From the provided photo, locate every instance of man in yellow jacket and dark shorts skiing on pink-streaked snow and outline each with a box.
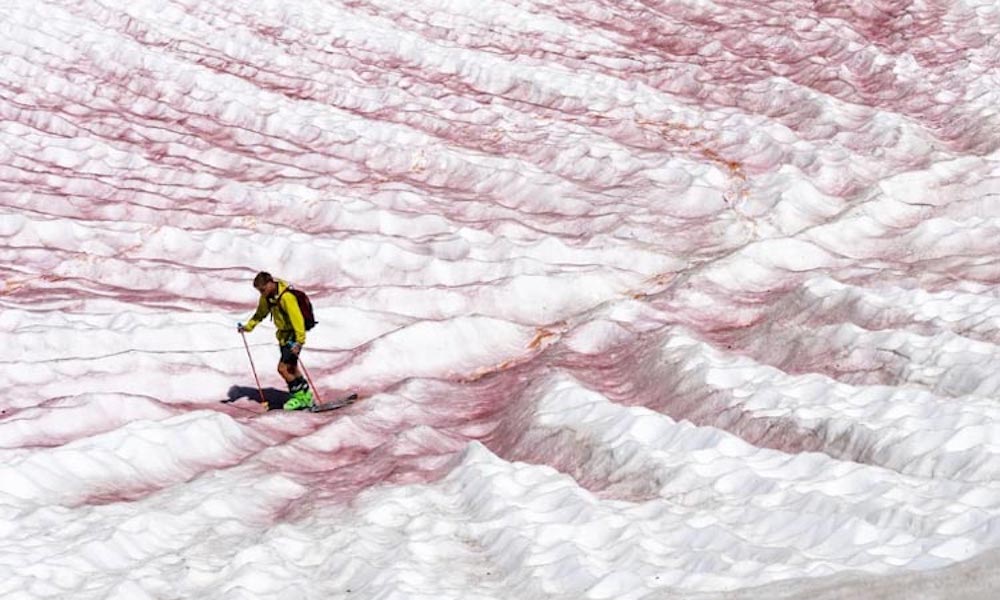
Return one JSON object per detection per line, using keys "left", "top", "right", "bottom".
{"left": 237, "top": 271, "right": 313, "bottom": 410}
